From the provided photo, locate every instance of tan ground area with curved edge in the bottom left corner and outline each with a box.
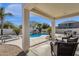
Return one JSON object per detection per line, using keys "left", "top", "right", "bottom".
{"left": 0, "top": 44, "right": 26, "bottom": 56}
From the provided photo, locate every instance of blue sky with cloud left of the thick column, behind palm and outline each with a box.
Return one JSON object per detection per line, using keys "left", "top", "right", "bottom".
{"left": 0, "top": 4, "right": 23, "bottom": 25}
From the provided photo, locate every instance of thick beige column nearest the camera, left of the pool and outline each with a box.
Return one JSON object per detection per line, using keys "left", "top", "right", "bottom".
{"left": 22, "top": 9, "right": 30, "bottom": 52}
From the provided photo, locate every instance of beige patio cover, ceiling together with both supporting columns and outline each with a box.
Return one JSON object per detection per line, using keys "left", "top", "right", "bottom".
{"left": 22, "top": 3, "right": 79, "bottom": 56}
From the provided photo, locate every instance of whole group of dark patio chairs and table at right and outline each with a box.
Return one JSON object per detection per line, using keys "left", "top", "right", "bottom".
{"left": 50, "top": 32, "right": 79, "bottom": 56}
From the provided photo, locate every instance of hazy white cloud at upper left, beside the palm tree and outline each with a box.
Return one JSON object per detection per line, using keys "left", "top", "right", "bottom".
{"left": 5, "top": 4, "right": 22, "bottom": 17}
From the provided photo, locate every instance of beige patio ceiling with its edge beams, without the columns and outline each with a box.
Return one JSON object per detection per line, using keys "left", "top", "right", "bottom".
{"left": 24, "top": 3, "right": 79, "bottom": 19}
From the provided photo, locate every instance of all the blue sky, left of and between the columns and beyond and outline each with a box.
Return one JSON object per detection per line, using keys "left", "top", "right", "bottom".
{"left": 0, "top": 3, "right": 79, "bottom": 26}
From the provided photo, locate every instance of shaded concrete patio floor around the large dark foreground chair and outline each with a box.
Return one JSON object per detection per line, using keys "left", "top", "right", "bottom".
{"left": 27, "top": 41, "right": 79, "bottom": 56}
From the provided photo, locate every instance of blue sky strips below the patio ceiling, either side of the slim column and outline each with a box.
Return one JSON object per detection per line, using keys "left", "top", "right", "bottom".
{"left": 30, "top": 14, "right": 79, "bottom": 26}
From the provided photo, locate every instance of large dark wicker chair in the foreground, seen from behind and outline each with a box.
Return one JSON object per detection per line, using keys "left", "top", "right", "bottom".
{"left": 50, "top": 42, "right": 78, "bottom": 56}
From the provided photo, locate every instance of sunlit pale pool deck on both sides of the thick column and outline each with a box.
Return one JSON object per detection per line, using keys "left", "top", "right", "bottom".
{"left": 5, "top": 35, "right": 48, "bottom": 48}
